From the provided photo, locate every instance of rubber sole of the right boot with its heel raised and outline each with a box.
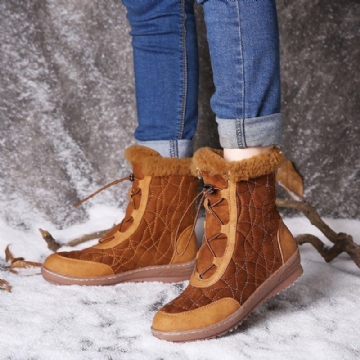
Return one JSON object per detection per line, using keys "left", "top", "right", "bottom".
{"left": 151, "top": 251, "right": 303, "bottom": 342}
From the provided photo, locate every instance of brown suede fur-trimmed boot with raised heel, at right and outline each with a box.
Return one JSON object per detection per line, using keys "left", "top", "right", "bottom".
{"left": 152, "top": 148, "right": 303, "bottom": 341}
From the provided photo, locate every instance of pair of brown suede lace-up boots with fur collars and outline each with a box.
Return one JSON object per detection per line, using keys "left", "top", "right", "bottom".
{"left": 42, "top": 145, "right": 302, "bottom": 341}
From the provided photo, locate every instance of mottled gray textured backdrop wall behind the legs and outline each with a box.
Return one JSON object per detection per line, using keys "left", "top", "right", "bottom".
{"left": 0, "top": 0, "right": 360, "bottom": 228}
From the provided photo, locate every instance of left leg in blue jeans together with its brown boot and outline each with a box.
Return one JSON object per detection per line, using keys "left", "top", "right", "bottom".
{"left": 42, "top": 0, "right": 202, "bottom": 285}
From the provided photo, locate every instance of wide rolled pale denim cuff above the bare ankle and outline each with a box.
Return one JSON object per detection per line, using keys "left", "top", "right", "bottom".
{"left": 216, "top": 113, "right": 283, "bottom": 149}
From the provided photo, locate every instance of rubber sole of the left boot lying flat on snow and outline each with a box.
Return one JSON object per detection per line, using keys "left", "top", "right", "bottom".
{"left": 41, "top": 260, "right": 195, "bottom": 286}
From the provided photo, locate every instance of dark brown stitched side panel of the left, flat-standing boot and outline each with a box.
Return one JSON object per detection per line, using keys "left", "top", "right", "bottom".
{"left": 61, "top": 176, "right": 198, "bottom": 273}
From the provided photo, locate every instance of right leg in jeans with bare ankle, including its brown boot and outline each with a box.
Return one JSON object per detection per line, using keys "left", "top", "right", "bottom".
{"left": 152, "top": 0, "right": 302, "bottom": 341}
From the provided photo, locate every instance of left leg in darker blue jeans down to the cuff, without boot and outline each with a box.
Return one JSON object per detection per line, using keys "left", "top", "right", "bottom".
{"left": 122, "top": 0, "right": 198, "bottom": 157}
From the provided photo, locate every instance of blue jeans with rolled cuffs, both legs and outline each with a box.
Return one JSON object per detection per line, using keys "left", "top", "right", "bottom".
{"left": 122, "top": 0, "right": 282, "bottom": 157}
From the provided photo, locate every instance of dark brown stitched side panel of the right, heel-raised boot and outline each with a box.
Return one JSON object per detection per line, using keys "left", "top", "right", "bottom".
{"left": 163, "top": 174, "right": 281, "bottom": 313}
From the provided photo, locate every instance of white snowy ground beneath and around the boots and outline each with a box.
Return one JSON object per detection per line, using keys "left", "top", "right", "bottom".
{"left": 0, "top": 205, "right": 360, "bottom": 360}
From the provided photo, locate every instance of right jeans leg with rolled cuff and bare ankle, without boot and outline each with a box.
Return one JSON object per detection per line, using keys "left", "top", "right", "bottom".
{"left": 200, "top": 0, "right": 282, "bottom": 160}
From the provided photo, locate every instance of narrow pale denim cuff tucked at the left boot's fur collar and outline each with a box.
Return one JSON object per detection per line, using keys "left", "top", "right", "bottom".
{"left": 136, "top": 140, "right": 193, "bottom": 158}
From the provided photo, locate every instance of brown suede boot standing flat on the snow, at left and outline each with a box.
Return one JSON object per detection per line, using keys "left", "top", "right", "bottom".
{"left": 41, "top": 145, "right": 198, "bottom": 285}
